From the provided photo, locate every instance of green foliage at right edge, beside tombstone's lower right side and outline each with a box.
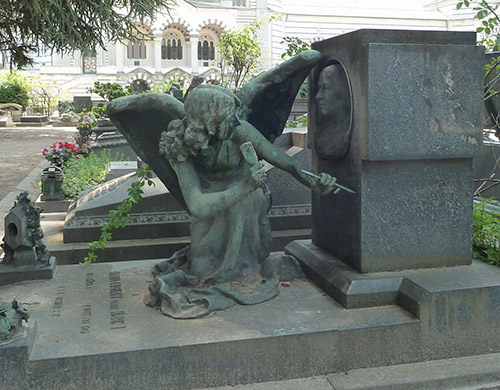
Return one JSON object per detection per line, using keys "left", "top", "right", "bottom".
{"left": 473, "top": 198, "right": 500, "bottom": 266}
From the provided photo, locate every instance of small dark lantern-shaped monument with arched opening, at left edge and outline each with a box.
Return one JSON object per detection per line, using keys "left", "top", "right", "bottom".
{"left": 0, "top": 192, "right": 55, "bottom": 285}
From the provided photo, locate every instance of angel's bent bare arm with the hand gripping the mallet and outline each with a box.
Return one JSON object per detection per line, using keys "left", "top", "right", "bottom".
{"left": 172, "top": 160, "right": 265, "bottom": 219}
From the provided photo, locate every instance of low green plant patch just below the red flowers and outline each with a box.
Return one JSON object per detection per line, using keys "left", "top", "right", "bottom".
{"left": 62, "top": 152, "right": 116, "bottom": 198}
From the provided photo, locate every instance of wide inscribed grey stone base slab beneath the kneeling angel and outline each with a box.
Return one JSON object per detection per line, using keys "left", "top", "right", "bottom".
{"left": 0, "top": 260, "right": 500, "bottom": 390}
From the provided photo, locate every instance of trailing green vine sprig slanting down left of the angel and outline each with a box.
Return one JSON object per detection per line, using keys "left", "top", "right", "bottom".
{"left": 83, "top": 165, "right": 154, "bottom": 264}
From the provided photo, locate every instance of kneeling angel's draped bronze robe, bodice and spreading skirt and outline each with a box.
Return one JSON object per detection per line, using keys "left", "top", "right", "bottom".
{"left": 145, "top": 140, "right": 297, "bottom": 318}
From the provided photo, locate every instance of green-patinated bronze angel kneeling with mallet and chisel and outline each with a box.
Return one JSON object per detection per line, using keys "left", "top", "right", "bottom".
{"left": 108, "top": 51, "right": 335, "bottom": 318}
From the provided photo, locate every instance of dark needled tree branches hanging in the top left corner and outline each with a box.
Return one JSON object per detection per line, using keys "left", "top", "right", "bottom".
{"left": 0, "top": 0, "right": 175, "bottom": 67}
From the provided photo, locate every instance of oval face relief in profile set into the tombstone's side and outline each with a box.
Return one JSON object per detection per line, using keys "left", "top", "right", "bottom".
{"left": 314, "top": 62, "right": 352, "bottom": 160}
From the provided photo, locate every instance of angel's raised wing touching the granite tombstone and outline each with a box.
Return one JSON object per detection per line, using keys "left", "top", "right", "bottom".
{"left": 237, "top": 50, "right": 321, "bottom": 142}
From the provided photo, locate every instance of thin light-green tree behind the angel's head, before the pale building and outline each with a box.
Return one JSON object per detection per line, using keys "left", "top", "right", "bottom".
{"left": 219, "top": 17, "right": 274, "bottom": 89}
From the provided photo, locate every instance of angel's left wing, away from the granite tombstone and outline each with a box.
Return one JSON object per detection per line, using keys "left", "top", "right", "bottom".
{"left": 107, "top": 93, "right": 187, "bottom": 209}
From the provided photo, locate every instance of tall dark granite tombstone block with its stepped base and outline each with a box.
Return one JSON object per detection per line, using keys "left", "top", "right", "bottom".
{"left": 286, "top": 30, "right": 500, "bottom": 364}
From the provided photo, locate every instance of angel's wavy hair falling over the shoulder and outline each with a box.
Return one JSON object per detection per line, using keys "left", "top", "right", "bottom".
{"left": 160, "top": 85, "right": 241, "bottom": 161}
